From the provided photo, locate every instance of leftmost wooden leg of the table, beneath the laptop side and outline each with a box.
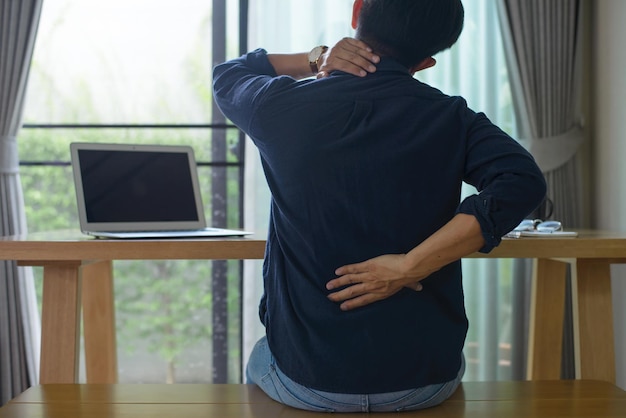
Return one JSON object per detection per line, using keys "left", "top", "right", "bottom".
{"left": 39, "top": 261, "right": 81, "bottom": 384}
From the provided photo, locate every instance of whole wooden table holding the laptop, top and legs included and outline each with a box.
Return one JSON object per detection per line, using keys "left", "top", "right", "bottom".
{"left": 0, "top": 231, "right": 626, "bottom": 383}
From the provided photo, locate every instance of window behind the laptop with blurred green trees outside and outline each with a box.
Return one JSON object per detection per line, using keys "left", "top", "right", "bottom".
{"left": 19, "top": 0, "right": 245, "bottom": 383}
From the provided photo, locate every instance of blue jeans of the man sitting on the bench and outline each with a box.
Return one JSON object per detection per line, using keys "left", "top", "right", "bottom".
{"left": 246, "top": 337, "right": 465, "bottom": 412}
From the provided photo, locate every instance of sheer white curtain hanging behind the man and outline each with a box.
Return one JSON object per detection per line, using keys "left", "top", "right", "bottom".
{"left": 243, "top": 0, "right": 526, "bottom": 380}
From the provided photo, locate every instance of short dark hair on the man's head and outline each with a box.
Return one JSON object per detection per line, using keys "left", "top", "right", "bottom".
{"left": 356, "top": 0, "right": 465, "bottom": 68}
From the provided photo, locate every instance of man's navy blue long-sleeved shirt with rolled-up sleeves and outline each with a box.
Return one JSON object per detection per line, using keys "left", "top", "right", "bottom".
{"left": 214, "top": 50, "right": 546, "bottom": 393}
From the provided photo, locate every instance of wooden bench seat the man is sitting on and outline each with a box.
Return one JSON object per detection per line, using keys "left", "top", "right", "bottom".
{"left": 0, "top": 380, "right": 626, "bottom": 418}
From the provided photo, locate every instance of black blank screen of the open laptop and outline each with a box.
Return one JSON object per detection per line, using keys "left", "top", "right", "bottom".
{"left": 78, "top": 150, "right": 198, "bottom": 222}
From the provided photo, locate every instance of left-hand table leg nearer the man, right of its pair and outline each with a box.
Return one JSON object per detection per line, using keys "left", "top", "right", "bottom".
{"left": 82, "top": 261, "right": 117, "bottom": 383}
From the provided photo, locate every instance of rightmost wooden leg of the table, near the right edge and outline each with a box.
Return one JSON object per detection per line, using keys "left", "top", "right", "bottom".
{"left": 572, "top": 259, "right": 615, "bottom": 383}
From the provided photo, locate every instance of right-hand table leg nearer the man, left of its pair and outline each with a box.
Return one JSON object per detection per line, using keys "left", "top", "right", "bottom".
{"left": 527, "top": 259, "right": 568, "bottom": 380}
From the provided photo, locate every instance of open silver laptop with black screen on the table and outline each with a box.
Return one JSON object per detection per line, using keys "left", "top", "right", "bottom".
{"left": 70, "top": 142, "right": 250, "bottom": 239}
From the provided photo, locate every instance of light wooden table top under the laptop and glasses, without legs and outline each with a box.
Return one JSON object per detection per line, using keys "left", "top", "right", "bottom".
{"left": 0, "top": 230, "right": 626, "bottom": 262}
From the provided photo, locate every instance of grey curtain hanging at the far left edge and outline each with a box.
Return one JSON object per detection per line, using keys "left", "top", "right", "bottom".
{"left": 0, "top": 0, "right": 42, "bottom": 405}
